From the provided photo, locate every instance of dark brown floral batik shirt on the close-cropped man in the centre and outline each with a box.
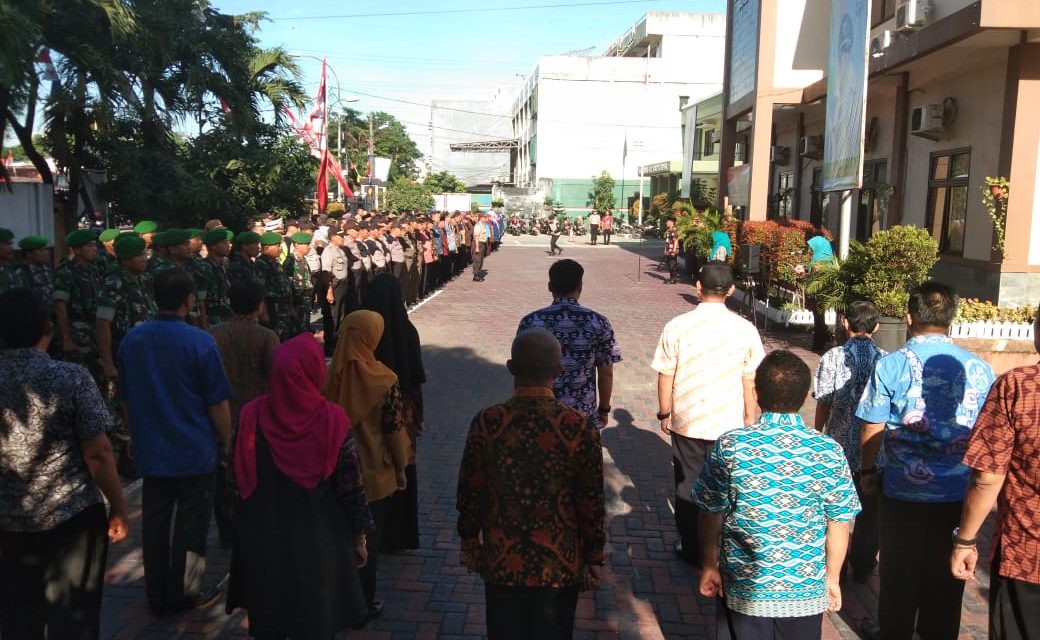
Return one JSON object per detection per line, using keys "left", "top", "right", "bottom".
{"left": 457, "top": 388, "right": 606, "bottom": 587}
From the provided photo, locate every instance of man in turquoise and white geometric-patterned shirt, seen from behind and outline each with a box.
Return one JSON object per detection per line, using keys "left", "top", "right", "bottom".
{"left": 693, "top": 351, "right": 860, "bottom": 640}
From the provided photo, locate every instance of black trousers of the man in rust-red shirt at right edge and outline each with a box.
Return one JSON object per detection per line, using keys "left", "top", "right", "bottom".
{"left": 989, "top": 544, "right": 1040, "bottom": 640}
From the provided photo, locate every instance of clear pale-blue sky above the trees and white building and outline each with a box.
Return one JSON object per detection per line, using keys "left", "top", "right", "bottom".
{"left": 211, "top": 0, "right": 726, "bottom": 159}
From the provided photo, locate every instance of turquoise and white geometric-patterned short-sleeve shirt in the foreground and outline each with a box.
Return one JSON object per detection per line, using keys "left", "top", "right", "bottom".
{"left": 693, "top": 413, "right": 860, "bottom": 618}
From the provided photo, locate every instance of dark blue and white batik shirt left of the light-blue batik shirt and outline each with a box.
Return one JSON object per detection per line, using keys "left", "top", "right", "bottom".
{"left": 812, "top": 337, "right": 885, "bottom": 470}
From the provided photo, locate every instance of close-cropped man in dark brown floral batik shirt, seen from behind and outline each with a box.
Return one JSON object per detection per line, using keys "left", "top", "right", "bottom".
{"left": 457, "top": 329, "right": 606, "bottom": 640}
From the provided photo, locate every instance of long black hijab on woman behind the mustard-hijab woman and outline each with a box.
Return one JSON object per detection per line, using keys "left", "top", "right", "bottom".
{"left": 365, "top": 274, "right": 426, "bottom": 391}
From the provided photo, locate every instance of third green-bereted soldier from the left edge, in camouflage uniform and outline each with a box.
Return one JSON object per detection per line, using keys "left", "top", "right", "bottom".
{"left": 54, "top": 229, "right": 105, "bottom": 382}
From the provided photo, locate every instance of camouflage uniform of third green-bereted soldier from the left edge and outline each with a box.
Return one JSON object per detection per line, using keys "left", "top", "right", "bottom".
{"left": 53, "top": 260, "right": 105, "bottom": 382}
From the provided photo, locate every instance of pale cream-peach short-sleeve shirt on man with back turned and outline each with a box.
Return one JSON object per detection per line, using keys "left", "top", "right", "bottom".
{"left": 650, "top": 302, "right": 765, "bottom": 440}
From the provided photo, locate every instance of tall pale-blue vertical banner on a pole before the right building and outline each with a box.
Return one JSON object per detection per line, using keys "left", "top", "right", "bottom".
{"left": 823, "top": 0, "right": 870, "bottom": 191}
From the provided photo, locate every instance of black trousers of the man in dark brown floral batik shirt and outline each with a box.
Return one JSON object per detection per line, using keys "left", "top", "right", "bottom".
{"left": 484, "top": 584, "right": 578, "bottom": 640}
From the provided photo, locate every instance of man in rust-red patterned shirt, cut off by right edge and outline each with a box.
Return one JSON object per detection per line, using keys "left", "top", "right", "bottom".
{"left": 951, "top": 303, "right": 1040, "bottom": 640}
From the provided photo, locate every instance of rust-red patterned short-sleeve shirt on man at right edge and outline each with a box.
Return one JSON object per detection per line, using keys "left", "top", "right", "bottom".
{"left": 964, "top": 364, "right": 1040, "bottom": 585}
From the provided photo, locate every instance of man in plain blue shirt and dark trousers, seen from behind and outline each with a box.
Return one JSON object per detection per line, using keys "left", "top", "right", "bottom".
{"left": 118, "top": 268, "right": 231, "bottom": 614}
